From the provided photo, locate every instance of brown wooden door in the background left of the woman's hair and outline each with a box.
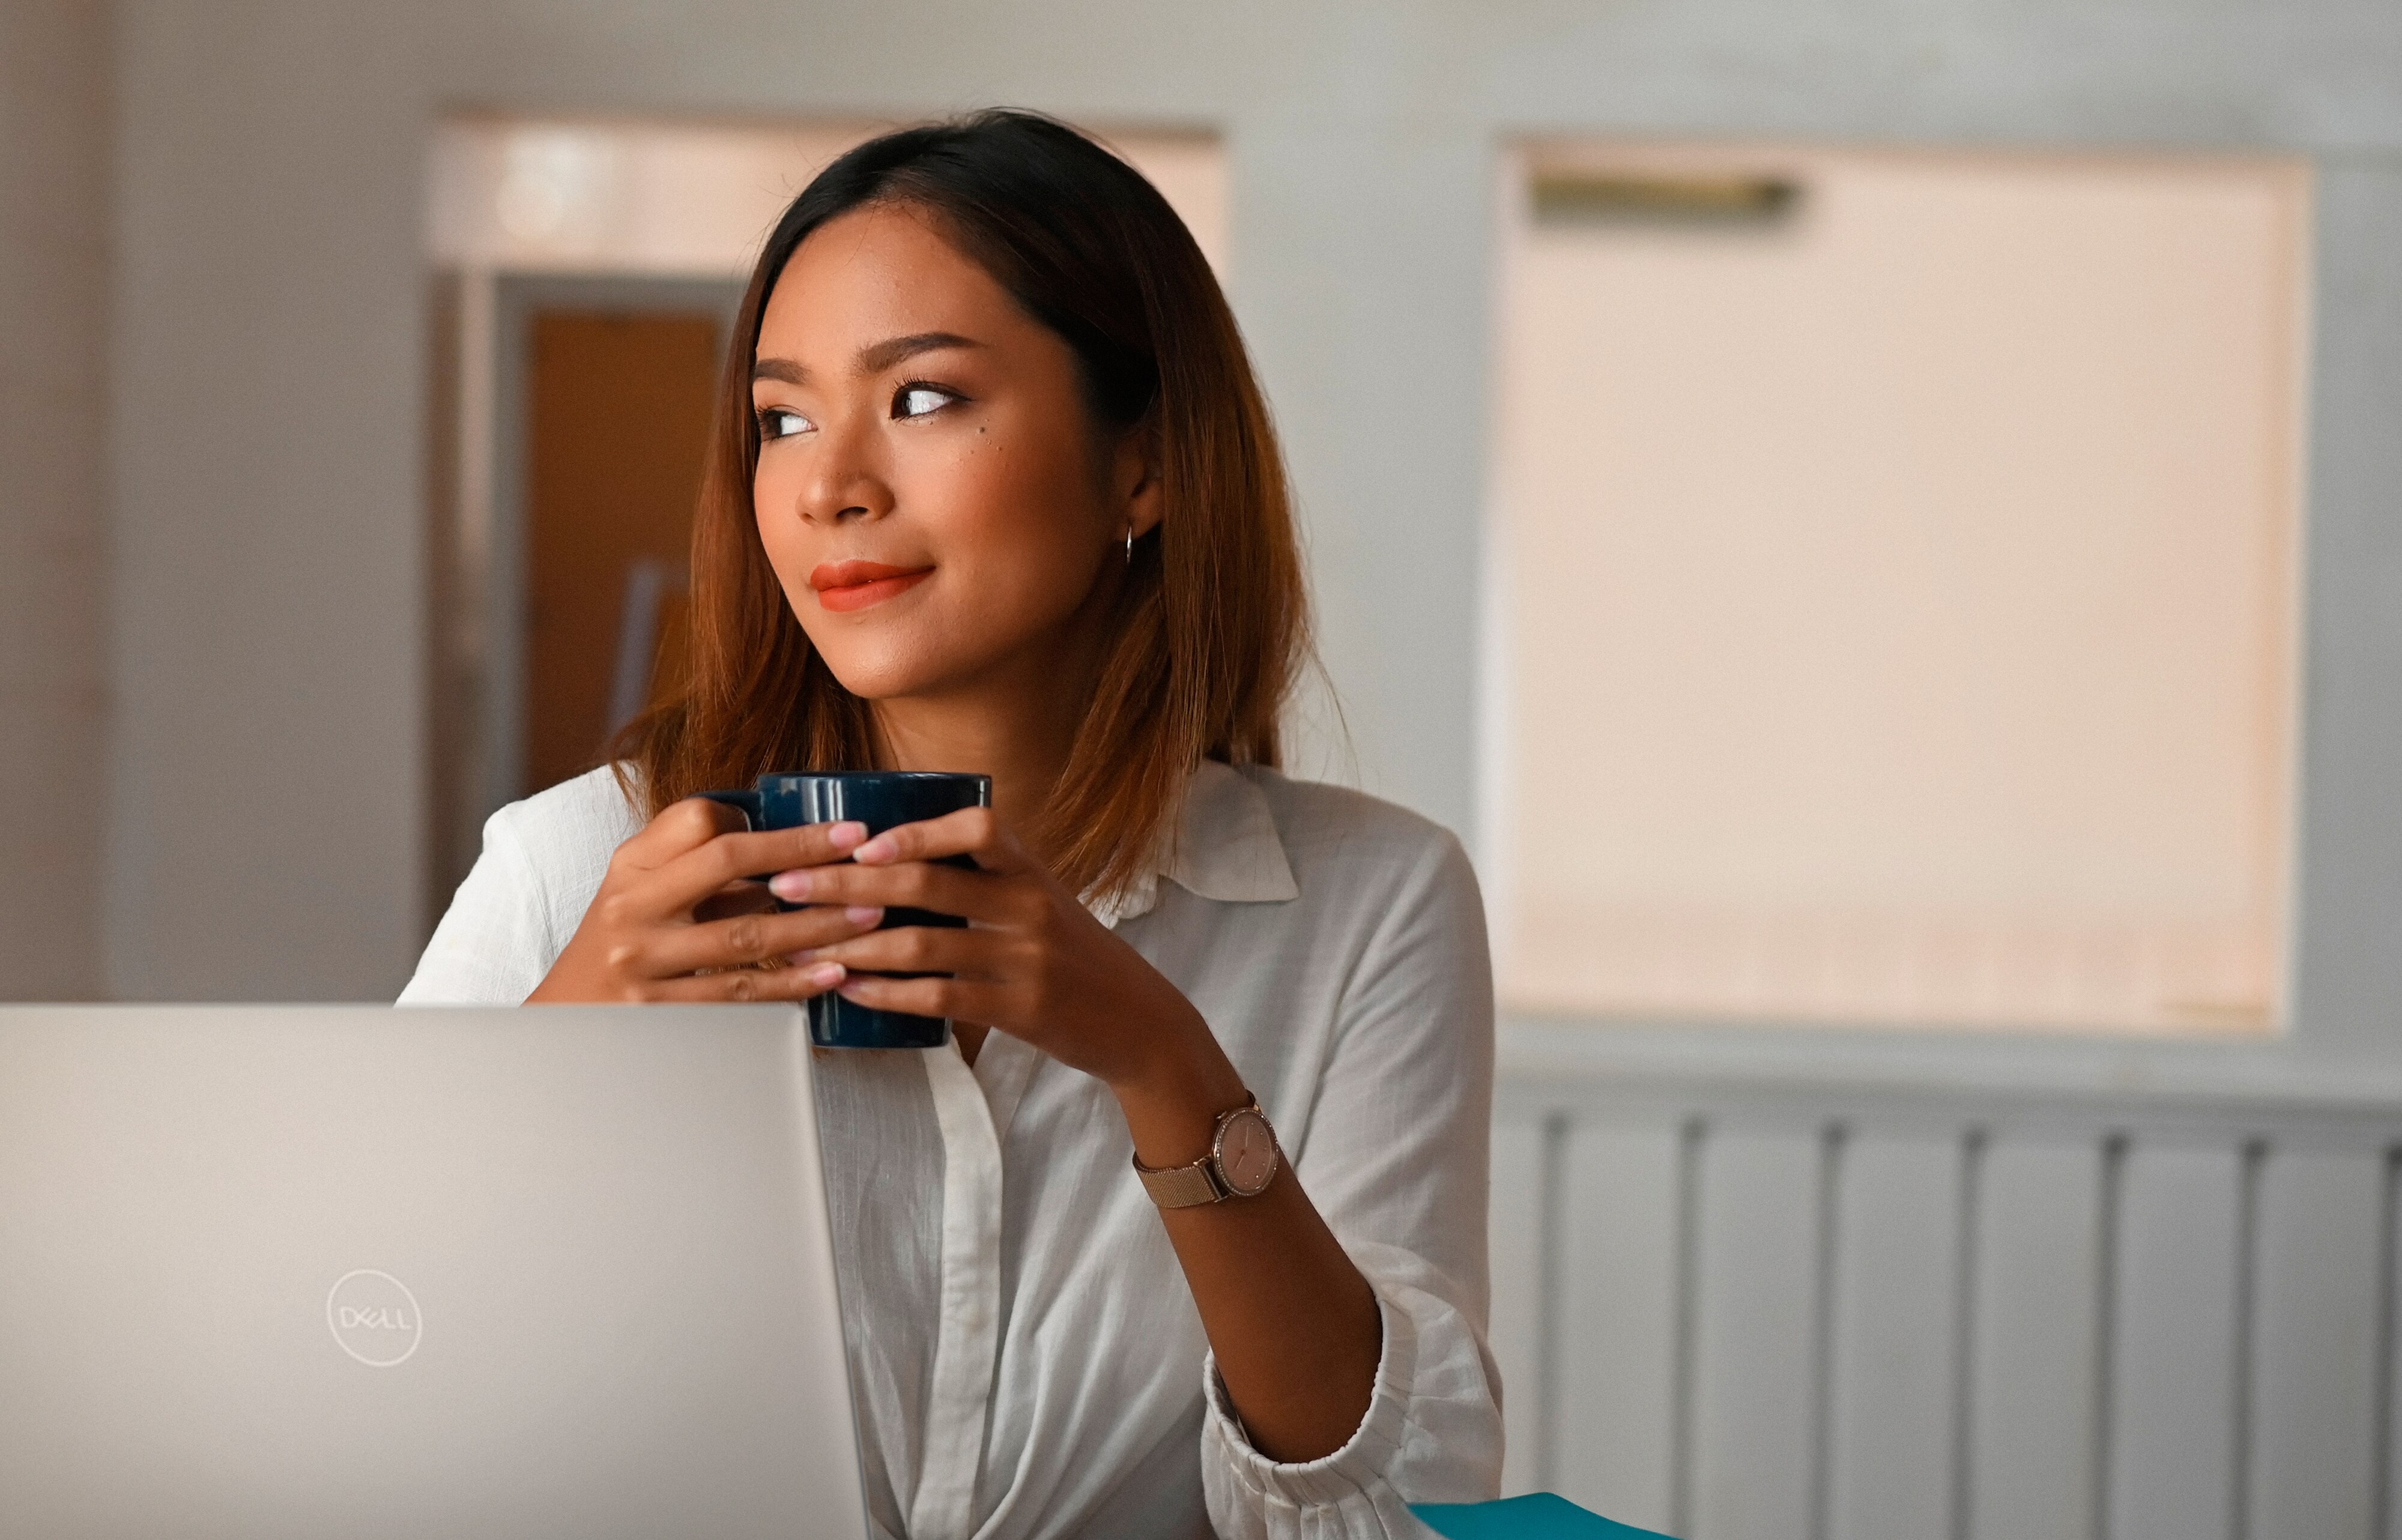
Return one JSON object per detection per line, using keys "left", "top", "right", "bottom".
{"left": 521, "top": 310, "right": 721, "bottom": 793}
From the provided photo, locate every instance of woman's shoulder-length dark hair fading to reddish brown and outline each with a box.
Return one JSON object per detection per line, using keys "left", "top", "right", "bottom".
{"left": 610, "top": 110, "right": 1309, "bottom": 894}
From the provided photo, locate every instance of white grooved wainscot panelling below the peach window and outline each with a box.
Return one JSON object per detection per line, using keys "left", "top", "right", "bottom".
{"left": 1492, "top": 1024, "right": 2402, "bottom": 1540}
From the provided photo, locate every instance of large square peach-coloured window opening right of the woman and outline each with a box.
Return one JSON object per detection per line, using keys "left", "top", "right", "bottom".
{"left": 1492, "top": 144, "right": 2311, "bottom": 1033}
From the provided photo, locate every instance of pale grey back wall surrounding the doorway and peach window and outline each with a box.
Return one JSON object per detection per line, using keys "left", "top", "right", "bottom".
{"left": 85, "top": 0, "right": 2402, "bottom": 1048}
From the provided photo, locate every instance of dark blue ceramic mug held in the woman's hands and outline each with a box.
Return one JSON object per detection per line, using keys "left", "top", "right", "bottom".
{"left": 701, "top": 772, "right": 992, "bottom": 1048}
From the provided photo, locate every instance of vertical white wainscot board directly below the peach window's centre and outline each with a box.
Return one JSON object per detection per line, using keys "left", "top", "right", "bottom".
{"left": 1828, "top": 1134, "right": 1962, "bottom": 1540}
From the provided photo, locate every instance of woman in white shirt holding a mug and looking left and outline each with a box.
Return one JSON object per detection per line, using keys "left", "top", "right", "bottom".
{"left": 404, "top": 113, "right": 1501, "bottom": 1540}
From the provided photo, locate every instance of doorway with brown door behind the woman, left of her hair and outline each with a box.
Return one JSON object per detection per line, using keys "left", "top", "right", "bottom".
{"left": 428, "top": 274, "right": 742, "bottom": 913}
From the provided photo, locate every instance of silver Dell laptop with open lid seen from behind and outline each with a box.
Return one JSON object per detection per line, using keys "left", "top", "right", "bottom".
{"left": 0, "top": 1007, "right": 867, "bottom": 1540}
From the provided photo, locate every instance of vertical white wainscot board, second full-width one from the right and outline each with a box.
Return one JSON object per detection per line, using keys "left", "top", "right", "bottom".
{"left": 2109, "top": 1144, "right": 2239, "bottom": 1540}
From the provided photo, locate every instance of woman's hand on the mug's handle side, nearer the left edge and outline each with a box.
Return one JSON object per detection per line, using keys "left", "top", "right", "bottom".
{"left": 526, "top": 798, "right": 884, "bottom": 1004}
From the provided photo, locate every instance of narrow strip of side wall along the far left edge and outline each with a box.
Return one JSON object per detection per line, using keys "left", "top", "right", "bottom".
{"left": 0, "top": 0, "right": 108, "bottom": 1000}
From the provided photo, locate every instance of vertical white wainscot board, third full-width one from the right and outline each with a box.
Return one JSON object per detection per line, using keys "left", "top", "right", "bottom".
{"left": 1967, "top": 1139, "right": 2102, "bottom": 1540}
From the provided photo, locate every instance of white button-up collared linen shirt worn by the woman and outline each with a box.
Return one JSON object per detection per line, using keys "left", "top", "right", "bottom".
{"left": 401, "top": 764, "right": 1501, "bottom": 1540}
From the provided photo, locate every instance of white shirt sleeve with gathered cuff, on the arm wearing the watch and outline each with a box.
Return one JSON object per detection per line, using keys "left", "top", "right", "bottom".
{"left": 1201, "top": 834, "right": 1501, "bottom": 1540}
